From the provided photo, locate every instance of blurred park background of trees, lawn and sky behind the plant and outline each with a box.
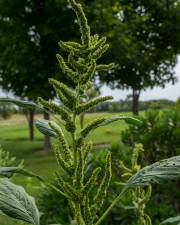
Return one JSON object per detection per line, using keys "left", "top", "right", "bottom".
{"left": 0, "top": 0, "right": 180, "bottom": 225}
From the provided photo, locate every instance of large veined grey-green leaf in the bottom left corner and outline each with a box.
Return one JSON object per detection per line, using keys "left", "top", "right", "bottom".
{"left": 0, "top": 178, "right": 40, "bottom": 225}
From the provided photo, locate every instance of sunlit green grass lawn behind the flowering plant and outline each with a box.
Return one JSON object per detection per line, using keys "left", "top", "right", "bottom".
{"left": 0, "top": 113, "right": 134, "bottom": 225}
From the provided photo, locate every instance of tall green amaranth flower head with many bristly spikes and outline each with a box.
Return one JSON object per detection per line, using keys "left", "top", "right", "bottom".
{"left": 38, "top": 0, "right": 113, "bottom": 225}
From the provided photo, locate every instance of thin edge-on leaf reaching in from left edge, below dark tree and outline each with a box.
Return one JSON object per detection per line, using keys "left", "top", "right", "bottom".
{"left": 0, "top": 98, "right": 39, "bottom": 109}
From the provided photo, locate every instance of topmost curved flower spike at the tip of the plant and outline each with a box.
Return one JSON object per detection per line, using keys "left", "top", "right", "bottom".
{"left": 69, "top": 0, "right": 90, "bottom": 47}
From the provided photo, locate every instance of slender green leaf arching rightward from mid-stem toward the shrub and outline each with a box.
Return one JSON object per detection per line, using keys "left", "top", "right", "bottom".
{"left": 99, "top": 116, "right": 141, "bottom": 126}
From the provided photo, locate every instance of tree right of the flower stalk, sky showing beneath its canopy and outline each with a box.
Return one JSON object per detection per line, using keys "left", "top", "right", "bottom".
{"left": 88, "top": 0, "right": 180, "bottom": 114}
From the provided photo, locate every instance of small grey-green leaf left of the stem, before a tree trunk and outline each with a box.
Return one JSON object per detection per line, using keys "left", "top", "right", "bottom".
{"left": 35, "top": 120, "right": 57, "bottom": 138}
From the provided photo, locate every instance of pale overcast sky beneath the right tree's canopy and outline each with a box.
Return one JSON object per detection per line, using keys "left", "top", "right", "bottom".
{"left": 101, "top": 57, "right": 180, "bottom": 100}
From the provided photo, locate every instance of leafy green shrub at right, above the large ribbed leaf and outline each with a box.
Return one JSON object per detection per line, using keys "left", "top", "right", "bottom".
{"left": 122, "top": 108, "right": 180, "bottom": 163}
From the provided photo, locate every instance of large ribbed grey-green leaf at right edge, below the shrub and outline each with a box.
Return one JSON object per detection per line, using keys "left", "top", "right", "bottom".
{"left": 125, "top": 156, "right": 180, "bottom": 189}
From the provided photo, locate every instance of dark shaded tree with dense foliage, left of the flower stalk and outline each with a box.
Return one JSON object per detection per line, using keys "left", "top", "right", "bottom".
{"left": 0, "top": 0, "right": 77, "bottom": 149}
